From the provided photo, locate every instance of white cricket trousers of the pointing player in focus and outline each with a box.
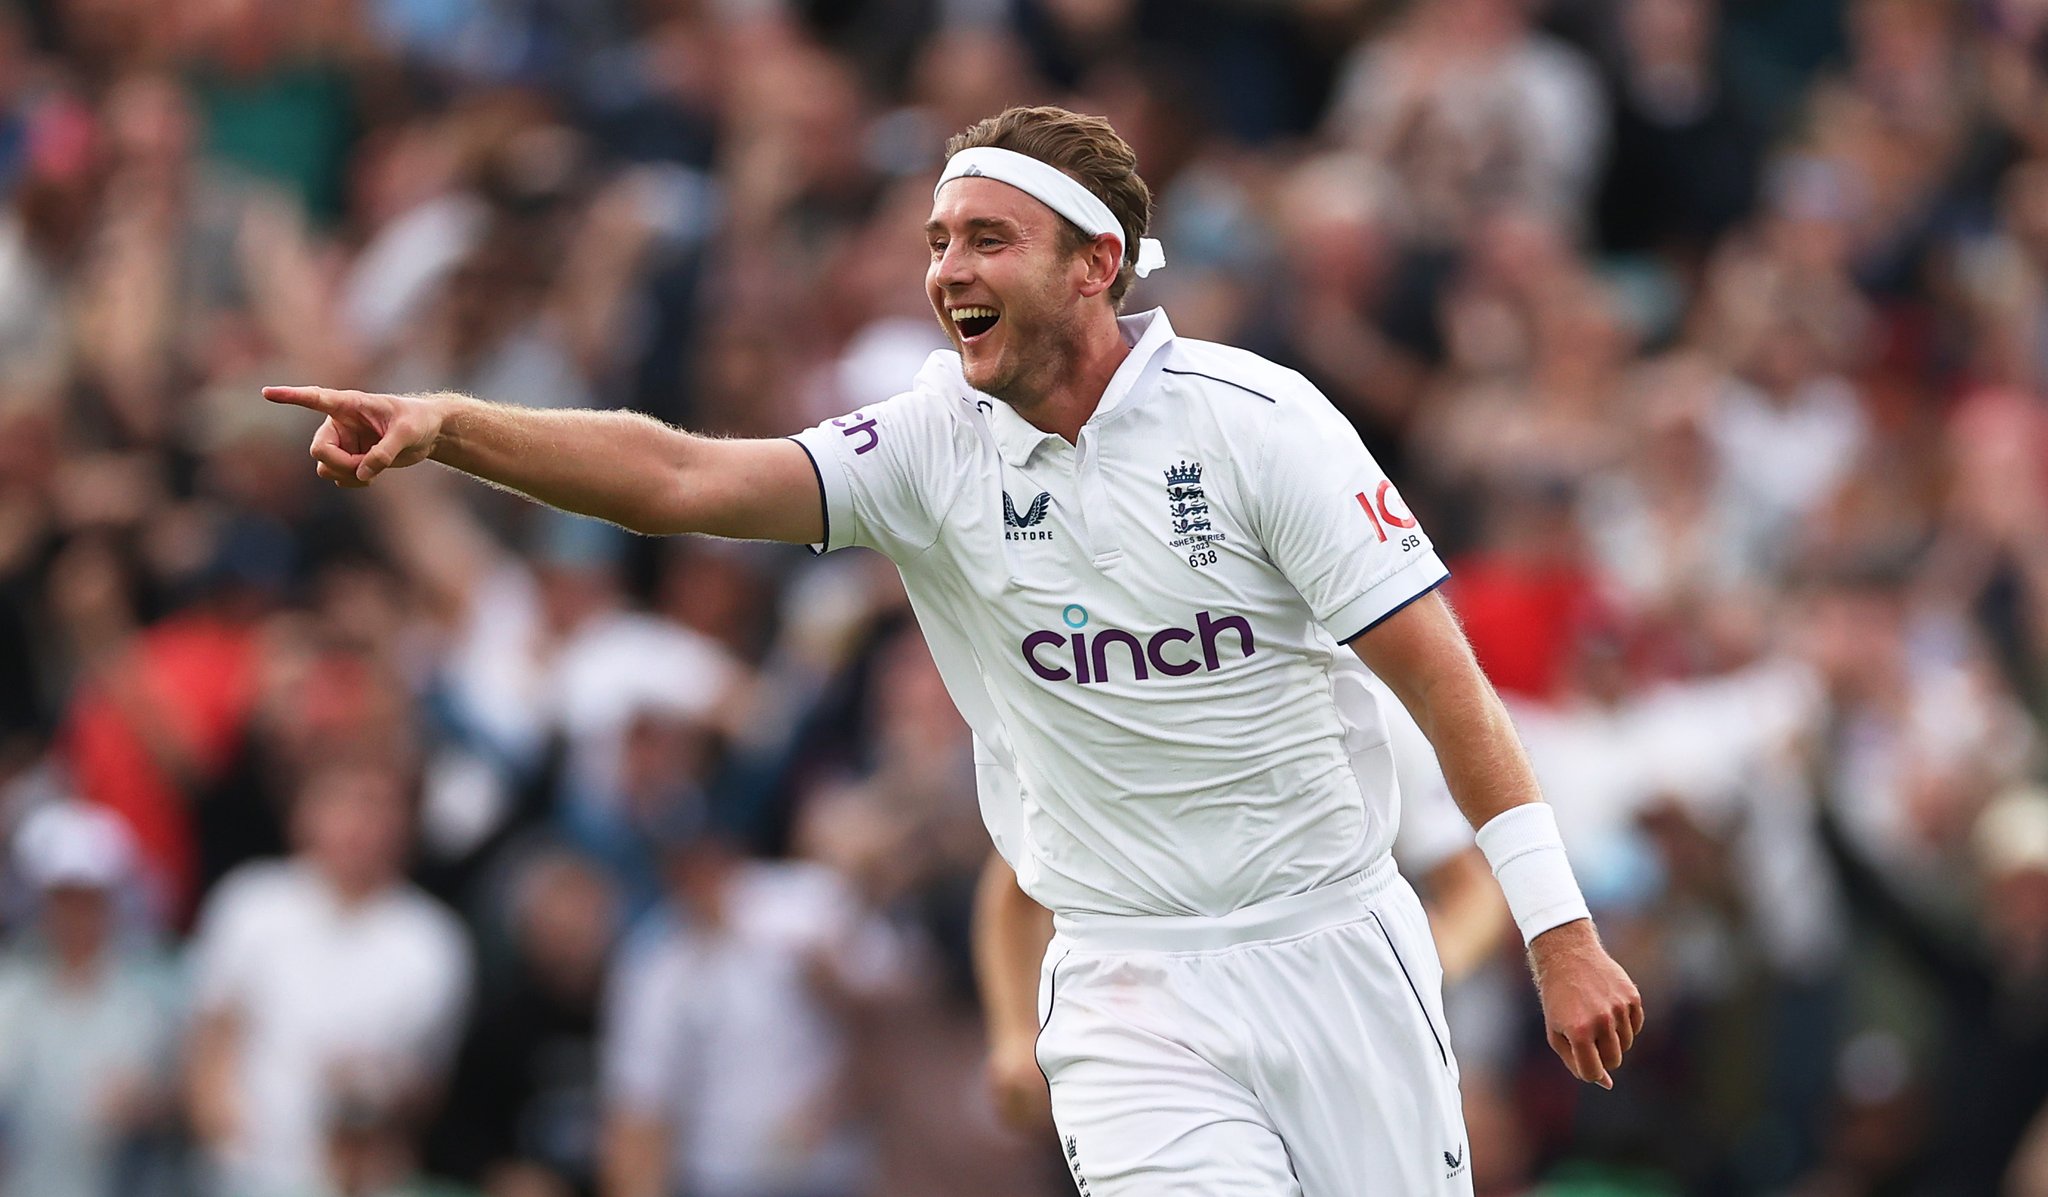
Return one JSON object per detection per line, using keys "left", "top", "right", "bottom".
{"left": 1038, "top": 859, "right": 1473, "bottom": 1197}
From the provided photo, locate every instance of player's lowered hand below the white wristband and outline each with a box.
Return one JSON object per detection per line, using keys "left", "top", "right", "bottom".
{"left": 1530, "top": 918, "right": 1642, "bottom": 1088}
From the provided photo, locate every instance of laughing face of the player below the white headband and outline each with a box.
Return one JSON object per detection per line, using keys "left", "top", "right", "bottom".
{"left": 924, "top": 178, "right": 1087, "bottom": 404}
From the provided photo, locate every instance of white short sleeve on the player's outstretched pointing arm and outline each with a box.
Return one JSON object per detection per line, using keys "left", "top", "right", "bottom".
{"left": 793, "top": 391, "right": 963, "bottom": 562}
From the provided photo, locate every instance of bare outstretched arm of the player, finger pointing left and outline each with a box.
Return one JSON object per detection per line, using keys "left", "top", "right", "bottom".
{"left": 262, "top": 387, "right": 825, "bottom": 543}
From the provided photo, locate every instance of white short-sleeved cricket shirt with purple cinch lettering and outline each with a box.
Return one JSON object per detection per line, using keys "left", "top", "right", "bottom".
{"left": 795, "top": 309, "right": 1448, "bottom": 916}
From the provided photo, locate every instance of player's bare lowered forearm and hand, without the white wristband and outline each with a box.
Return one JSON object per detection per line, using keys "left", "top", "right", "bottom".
{"left": 1352, "top": 594, "right": 1642, "bottom": 1088}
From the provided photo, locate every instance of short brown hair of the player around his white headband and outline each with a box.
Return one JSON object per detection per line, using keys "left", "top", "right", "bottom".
{"left": 946, "top": 105, "right": 1151, "bottom": 307}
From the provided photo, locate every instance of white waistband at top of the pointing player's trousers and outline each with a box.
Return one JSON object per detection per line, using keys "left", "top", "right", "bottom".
{"left": 1053, "top": 855, "right": 1401, "bottom": 951}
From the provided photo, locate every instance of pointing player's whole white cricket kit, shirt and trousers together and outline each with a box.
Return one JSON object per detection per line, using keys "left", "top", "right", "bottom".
{"left": 797, "top": 312, "right": 1470, "bottom": 1197}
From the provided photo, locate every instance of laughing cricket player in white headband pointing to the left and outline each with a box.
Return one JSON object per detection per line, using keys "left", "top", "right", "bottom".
{"left": 264, "top": 109, "right": 1642, "bottom": 1197}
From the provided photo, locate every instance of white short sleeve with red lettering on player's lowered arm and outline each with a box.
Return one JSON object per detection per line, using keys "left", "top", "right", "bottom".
{"left": 1251, "top": 387, "right": 1450, "bottom": 644}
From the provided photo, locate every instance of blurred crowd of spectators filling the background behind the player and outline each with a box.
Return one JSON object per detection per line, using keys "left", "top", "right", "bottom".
{"left": 0, "top": 0, "right": 2048, "bottom": 1197}
